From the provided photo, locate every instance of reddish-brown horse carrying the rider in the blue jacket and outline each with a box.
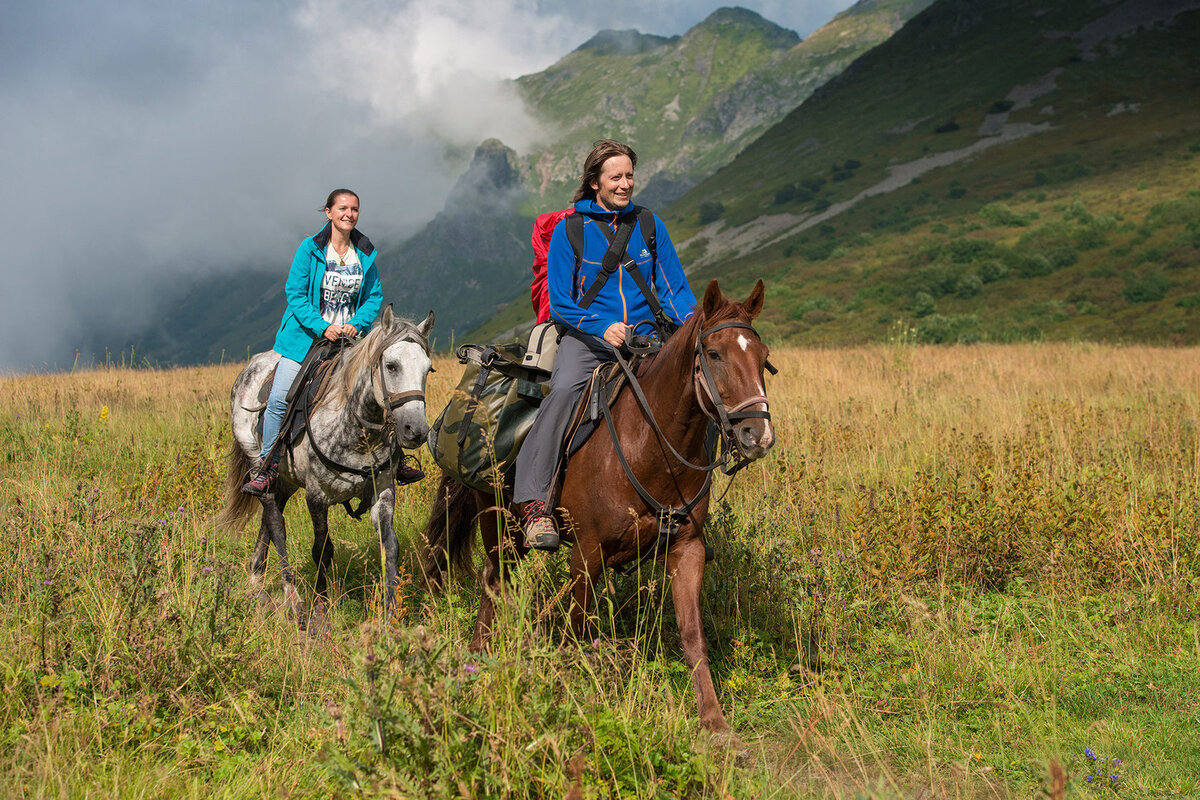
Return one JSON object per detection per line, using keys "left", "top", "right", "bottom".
{"left": 425, "top": 281, "right": 774, "bottom": 732}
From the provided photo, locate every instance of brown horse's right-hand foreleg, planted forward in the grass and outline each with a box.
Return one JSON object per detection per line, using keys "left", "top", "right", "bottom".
{"left": 667, "top": 536, "right": 730, "bottom": 733}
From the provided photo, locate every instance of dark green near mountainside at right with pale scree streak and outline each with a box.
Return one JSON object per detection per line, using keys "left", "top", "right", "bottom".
{"left": 665, "top": 0, "right": 1200, "bottom": 343}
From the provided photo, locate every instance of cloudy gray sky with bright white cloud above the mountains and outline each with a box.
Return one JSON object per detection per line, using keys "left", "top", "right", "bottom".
{"left": 0, "top": 0, "right": 852, "bottom": 373}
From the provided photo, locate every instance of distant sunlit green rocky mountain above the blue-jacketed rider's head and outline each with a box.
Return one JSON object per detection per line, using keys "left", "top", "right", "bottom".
{"left": 517, "top": 0, "right": 929, "bottom": 207}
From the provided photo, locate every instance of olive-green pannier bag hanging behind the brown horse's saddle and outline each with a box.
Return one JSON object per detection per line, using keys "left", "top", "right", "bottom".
{"left": 427, "top": 342, "right": 550, "bottom": 492}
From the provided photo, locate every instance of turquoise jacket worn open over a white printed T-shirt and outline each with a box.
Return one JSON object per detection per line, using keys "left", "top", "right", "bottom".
{"left": 272, "top": 223, "right": 381, "bottom": 361}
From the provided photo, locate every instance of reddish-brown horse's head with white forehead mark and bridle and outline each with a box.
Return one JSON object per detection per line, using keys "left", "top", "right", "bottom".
{"left": 695, "top": 281, "right": 775, "bottom": 461}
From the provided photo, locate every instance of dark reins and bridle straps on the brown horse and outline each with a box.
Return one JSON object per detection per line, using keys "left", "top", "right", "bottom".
{"left": 600, "top": 321, "right": 776, "bottom": 561}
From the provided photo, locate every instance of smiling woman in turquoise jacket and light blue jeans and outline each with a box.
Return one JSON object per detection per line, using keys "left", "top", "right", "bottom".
{"left": 241, "top": 188, "right": 386, "bottom": 495}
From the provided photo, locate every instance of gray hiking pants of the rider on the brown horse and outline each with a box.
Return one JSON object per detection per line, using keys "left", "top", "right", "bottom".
{"left": 512, "top": 331, "right": 616, "bottom": 506}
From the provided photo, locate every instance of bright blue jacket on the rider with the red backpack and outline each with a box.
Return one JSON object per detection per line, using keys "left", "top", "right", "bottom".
{"left": 546, "top": 200, "right": 696, "bottom": 337}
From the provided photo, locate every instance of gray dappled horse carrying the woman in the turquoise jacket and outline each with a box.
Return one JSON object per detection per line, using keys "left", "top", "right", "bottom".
{"left": 218, "top": 306, "right": 433, "bottom": 633}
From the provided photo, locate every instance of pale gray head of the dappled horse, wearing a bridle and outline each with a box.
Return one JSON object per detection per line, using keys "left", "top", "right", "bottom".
{"left": 371, "top": 305, "right": 433, "bottom": 447}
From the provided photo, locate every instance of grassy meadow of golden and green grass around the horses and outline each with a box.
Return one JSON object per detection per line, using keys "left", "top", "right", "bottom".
{"left": 0, "top": 340, "right": 1200, "bottom": 800}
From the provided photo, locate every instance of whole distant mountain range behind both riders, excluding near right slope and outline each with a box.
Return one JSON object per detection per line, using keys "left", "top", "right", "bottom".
{"left": 124, "top": 0, "right": 930, "bottom": 363}
